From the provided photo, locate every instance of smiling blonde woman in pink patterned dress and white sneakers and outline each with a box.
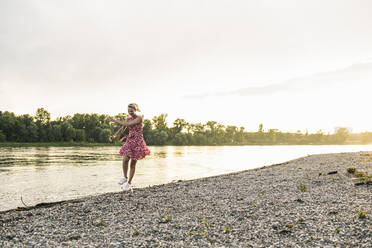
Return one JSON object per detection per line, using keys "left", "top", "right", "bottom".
{"left": 108, "top": 103, "right": 150, "bottom": 191}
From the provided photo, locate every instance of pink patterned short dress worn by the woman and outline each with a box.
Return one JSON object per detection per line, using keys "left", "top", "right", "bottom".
{"left": 119, "top": 117, "right": 150, "bottom": 160}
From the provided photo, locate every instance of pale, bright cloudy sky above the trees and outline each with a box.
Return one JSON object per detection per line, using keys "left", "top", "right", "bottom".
{"left": 0, "top": 0, "right": 372, "bottom": 132}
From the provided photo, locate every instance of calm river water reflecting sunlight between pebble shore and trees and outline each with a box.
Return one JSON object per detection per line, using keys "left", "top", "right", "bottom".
{"left": 0, "top": 145, "right": 372, "bottom": 210}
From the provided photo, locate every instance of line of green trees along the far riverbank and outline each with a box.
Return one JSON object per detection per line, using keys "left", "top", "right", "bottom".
{"left": 0, "top": 108, "right": 372, "bottom": 145}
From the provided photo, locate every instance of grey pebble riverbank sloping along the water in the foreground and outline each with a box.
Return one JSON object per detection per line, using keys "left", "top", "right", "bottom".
{"left": 0, "top": 152, "right": 372, "bottom": 247}
